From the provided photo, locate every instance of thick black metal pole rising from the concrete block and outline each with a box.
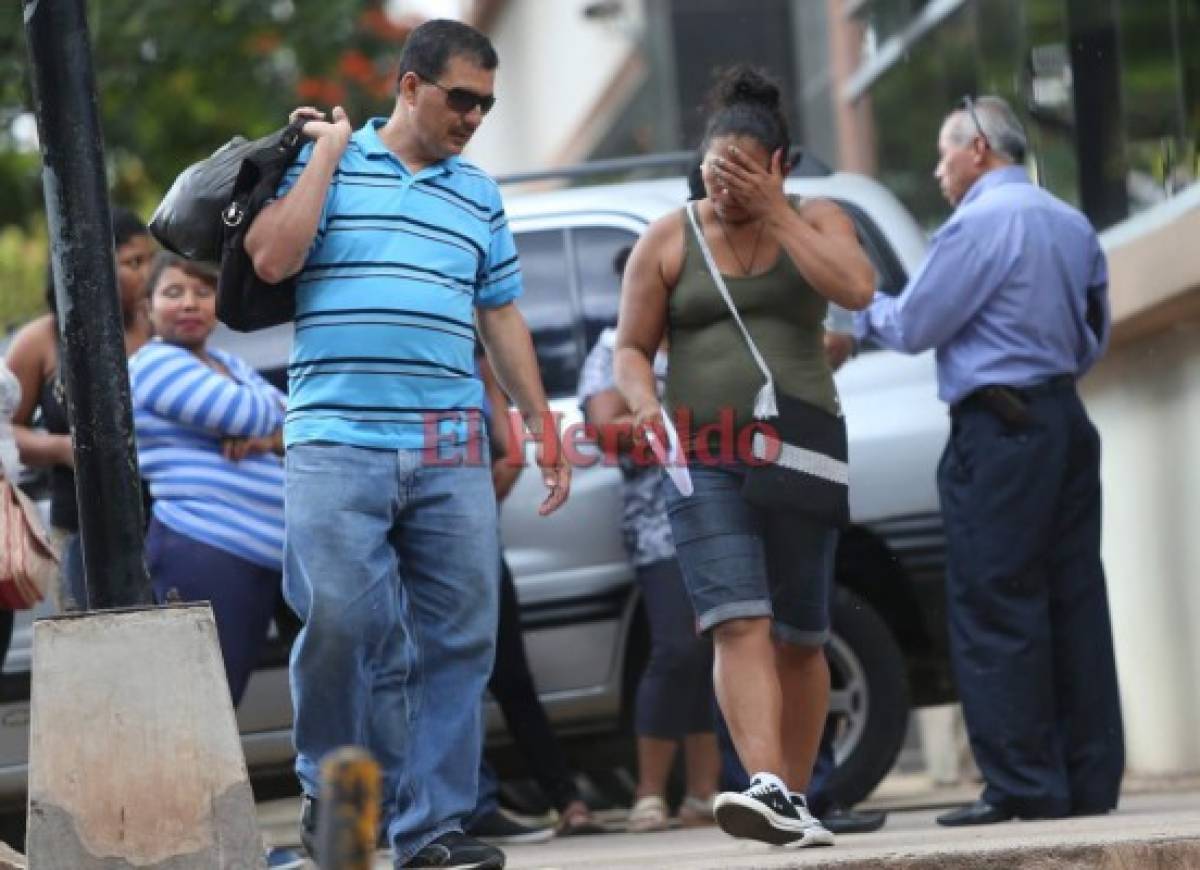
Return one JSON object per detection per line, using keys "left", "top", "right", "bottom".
{"left": 24, "top": 0, "right": 152, "bottom": 608}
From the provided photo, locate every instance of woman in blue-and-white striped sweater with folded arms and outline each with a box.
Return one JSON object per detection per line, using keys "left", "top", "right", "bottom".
{"left": 130, "top": 253, "right": 284, "bottom": 704}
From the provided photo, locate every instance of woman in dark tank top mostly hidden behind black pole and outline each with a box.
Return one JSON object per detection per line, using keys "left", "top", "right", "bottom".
{"left": 6, "top": 208, "right": 155, "bottom": 611}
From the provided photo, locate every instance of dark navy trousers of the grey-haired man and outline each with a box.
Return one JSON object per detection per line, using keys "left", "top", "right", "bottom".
{"left": 937, "top": 384, "right": 1124, "bottom": 817}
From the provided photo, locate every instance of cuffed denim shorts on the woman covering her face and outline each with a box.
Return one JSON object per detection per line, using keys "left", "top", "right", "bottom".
{"left": 666, "top": 464, "right": 838, "bottom": 647}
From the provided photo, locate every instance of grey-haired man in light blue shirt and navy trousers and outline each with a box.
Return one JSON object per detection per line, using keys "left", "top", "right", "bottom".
{"left": 854, "top": 97, "right": 1124, "bottom": 826}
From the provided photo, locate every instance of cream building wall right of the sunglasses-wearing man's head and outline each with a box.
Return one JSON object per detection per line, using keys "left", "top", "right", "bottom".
{"left": 467, "top": 0, "right": 641, "bottom": 174}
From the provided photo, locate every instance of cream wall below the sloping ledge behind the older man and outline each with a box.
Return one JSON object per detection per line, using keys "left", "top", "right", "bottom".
{"left": 1081, "top": 319, "right": 1200, "bottom": 774}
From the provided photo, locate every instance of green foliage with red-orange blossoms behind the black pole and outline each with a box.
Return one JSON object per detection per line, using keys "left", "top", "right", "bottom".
{"left": 0, "top": 0, "right": 407, "bottom": 324}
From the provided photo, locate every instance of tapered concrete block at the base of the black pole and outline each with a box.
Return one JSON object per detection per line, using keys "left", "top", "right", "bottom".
{"left": 26, "top": 604, "right": 263, "bottom": 870}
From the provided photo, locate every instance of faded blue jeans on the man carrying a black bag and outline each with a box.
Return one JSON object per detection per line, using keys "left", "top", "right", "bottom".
{"left": 283, "top": 444, "right": 498, "bottom": 860}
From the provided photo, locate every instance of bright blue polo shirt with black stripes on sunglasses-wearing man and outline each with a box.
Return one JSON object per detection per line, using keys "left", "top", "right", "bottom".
{"left": 278, "top": 118, "right": 521, "bottom": 449}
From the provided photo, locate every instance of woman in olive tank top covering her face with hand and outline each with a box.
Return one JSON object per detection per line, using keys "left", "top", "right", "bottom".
{"left": 616, "top": 66, "right": 875, "bottom": 846}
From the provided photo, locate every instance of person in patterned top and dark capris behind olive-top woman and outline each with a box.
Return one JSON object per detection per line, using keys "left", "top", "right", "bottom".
{"left": 577, "top": 247, "right": 720, "bottom": 833}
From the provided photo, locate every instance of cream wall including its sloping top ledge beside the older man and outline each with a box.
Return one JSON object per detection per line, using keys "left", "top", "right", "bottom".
{"left": 1081, "top": 186, "right": 1200, "bottom": 774}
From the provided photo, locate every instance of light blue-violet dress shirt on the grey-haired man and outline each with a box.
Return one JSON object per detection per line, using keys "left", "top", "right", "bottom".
{"left": 854, "top": 167, "right": 1109, "bottom": 404}
